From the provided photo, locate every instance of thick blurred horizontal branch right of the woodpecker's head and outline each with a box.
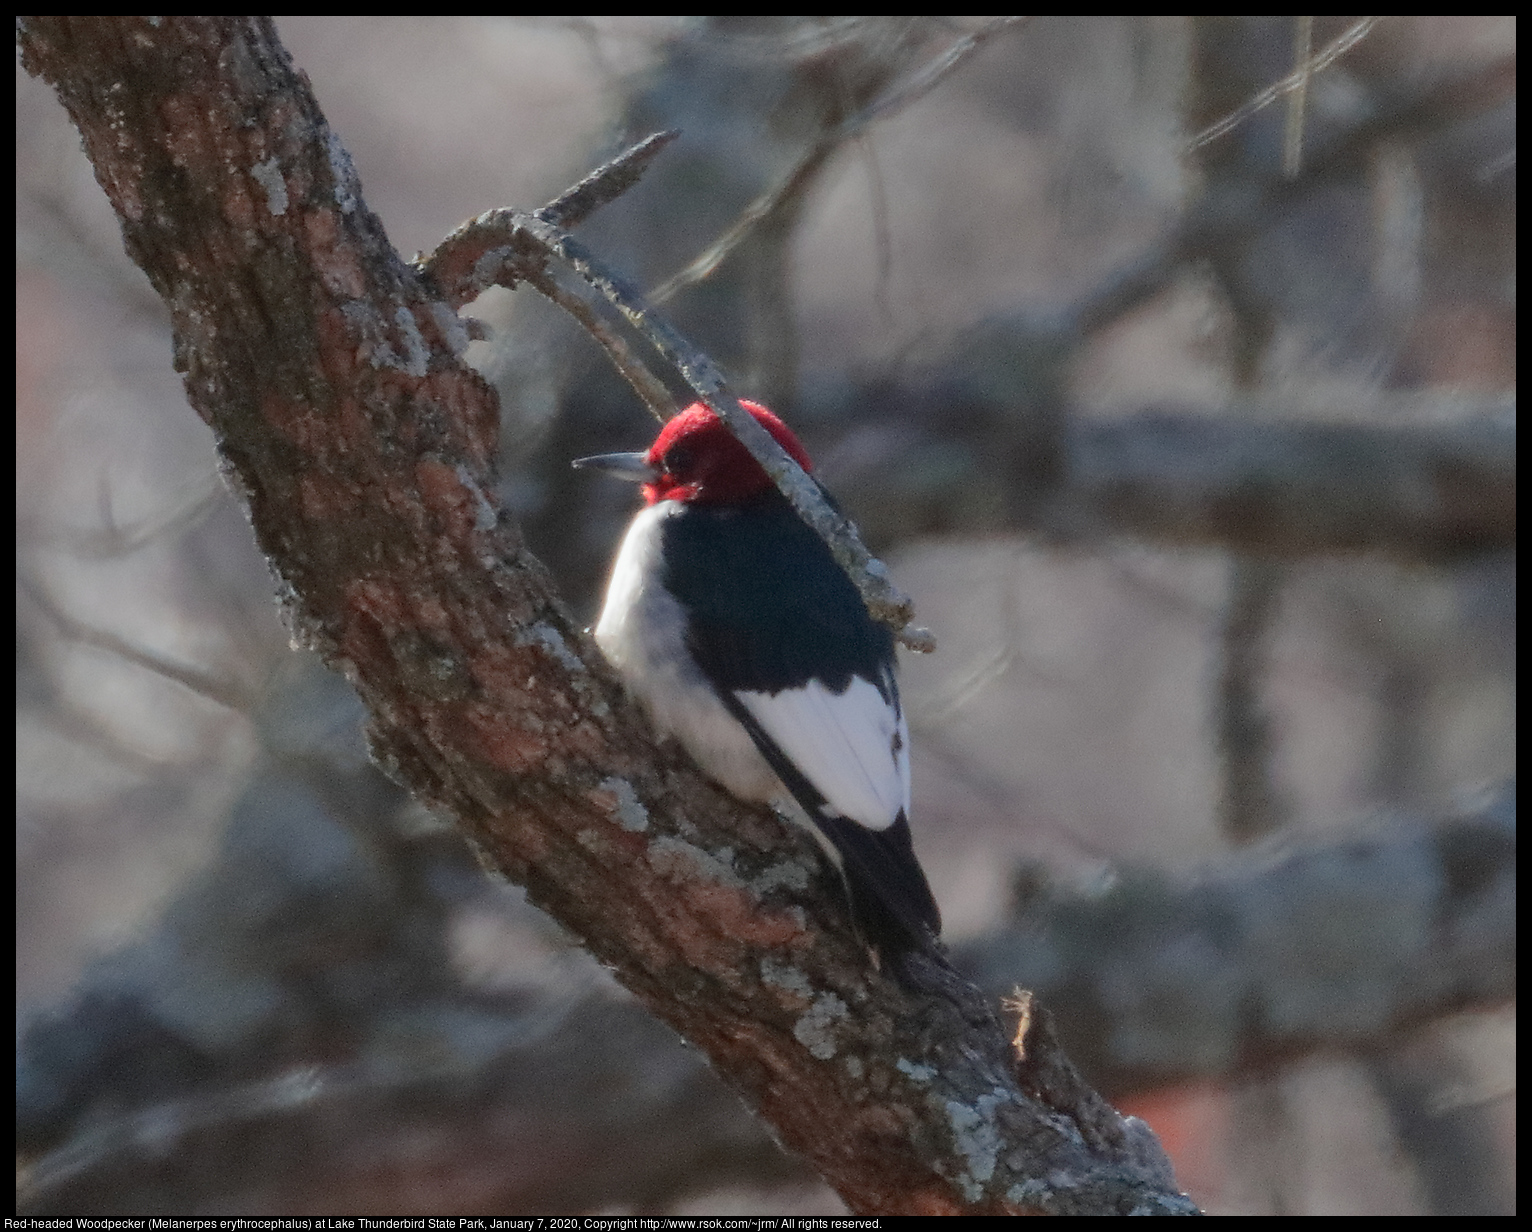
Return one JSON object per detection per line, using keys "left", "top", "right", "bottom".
{"left": 815, "top": 385, "right": 1517, "bottom": 562}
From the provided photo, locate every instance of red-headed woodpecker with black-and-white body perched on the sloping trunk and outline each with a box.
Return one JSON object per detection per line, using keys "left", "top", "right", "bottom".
{"left": 575, "top": 401, "right": 941, "bottom": 955}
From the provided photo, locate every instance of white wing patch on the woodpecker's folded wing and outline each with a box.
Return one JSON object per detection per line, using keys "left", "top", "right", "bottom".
{"left": 734, "top": 676, "right": 910, "bottom": 831}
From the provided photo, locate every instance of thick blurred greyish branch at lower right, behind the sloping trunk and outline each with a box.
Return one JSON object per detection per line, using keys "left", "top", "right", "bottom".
{"left": 958, "top": 785, "right": 1517, "bottom": 1094}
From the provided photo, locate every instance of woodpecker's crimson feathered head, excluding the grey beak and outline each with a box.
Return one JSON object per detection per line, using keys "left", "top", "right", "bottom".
{"left": 643, "top": 398, "right": 810, "bottom": 504}
